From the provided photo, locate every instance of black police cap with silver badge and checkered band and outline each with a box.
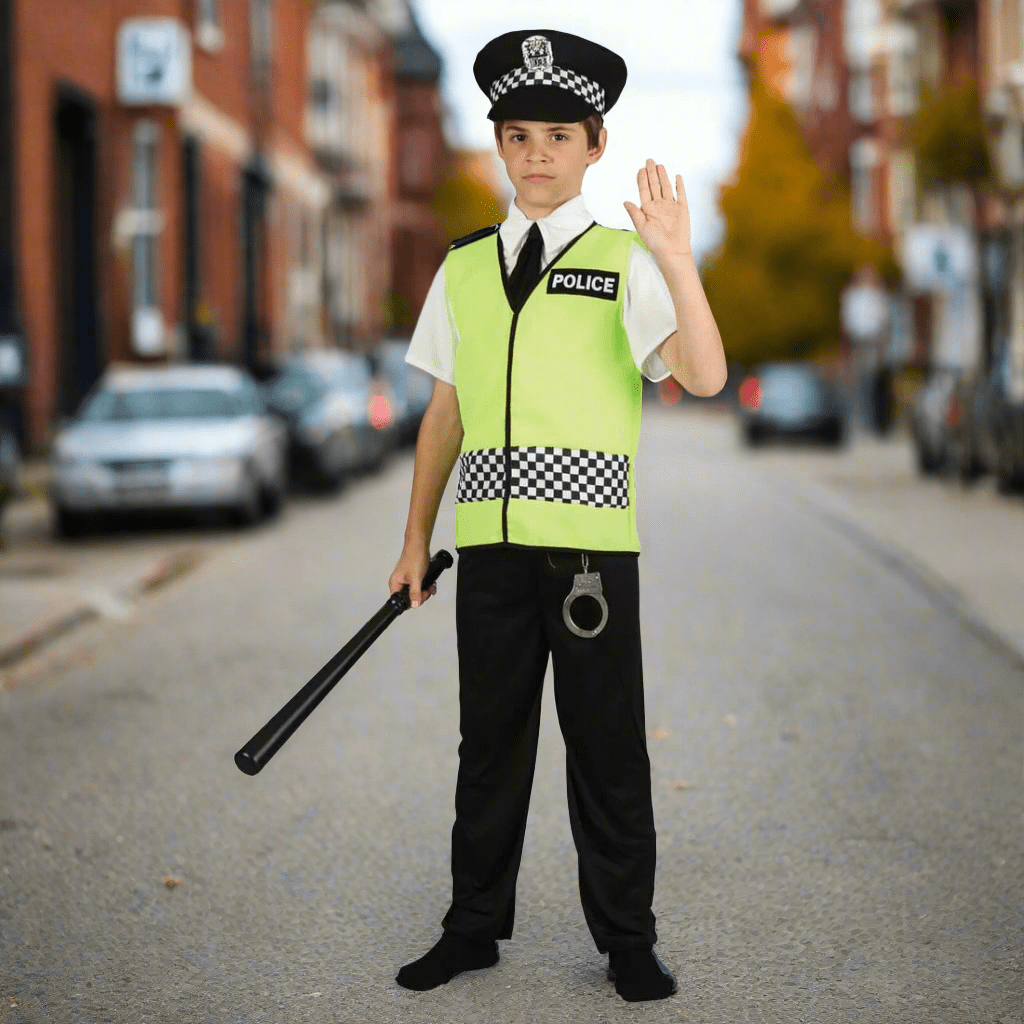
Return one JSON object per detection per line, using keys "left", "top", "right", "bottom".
{"left": 473, "top": 29, "right": 626, "bottom": 124}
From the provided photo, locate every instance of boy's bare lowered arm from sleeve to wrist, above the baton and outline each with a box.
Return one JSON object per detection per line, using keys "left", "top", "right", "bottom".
{"left": 406, "top": 380, "right": 463, "bottom": 548}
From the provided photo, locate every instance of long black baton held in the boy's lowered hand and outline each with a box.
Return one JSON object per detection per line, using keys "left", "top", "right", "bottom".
{"left": 234, "top": 548, "right": 453, "bottom": 775}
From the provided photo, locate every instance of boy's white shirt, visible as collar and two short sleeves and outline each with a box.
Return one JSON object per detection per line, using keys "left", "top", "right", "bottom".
{"left": 406, "top": 195, "right": 677, "bottom": 386}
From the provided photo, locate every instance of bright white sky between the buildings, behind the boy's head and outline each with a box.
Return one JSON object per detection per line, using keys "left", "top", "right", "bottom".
{"left": 412, "top": 0, "right": 749, "bottom": 261}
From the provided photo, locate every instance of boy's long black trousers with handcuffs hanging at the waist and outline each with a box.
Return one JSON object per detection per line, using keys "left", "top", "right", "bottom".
{"left": 441, "top": 547, "right": 657, "bottom": 953}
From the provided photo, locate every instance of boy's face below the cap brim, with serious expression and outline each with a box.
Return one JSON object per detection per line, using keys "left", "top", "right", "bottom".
{"left": 498, "top": 120, "right": 608, "bottom": 215}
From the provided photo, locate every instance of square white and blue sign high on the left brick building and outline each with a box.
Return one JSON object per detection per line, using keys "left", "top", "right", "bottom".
{"left": 118, "top": 17, "right": 191, "bottom": 106}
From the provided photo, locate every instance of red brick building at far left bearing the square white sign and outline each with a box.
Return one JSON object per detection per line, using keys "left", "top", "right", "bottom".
{"left": 3, "top": 0, "right": 330, "bottom": 452}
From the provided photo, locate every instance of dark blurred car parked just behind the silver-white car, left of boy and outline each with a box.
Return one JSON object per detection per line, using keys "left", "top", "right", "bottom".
{"left": 265, "top": 349, "right": 397, "bottom": 487}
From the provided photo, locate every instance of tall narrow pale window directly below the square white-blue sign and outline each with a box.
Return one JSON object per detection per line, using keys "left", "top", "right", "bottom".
{"left": 132, "top": 120, "right": 164, "bottom": 355}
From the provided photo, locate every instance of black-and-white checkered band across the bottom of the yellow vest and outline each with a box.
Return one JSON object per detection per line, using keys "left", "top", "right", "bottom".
{"left": 455, "top": 447, "right": 630, "bottom": 509}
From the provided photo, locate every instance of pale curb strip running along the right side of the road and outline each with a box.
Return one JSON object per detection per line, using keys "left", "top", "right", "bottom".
{"left": 783, "top": 470, "right": 1024, "bottom": 671}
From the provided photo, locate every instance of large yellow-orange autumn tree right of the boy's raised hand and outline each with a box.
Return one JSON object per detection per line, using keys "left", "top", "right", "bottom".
{"left": 701, "top": 71, "right": 899, "bottom": 366}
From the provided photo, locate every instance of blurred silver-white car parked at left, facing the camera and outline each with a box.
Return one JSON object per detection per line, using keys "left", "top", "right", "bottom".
{"left": 49, "top": 364, "right": 288, "bottom": 537}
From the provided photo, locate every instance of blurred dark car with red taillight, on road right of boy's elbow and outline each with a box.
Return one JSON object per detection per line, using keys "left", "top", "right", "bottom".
{"left": 738, "top": 360, "right": 847, "bottom": 445}
